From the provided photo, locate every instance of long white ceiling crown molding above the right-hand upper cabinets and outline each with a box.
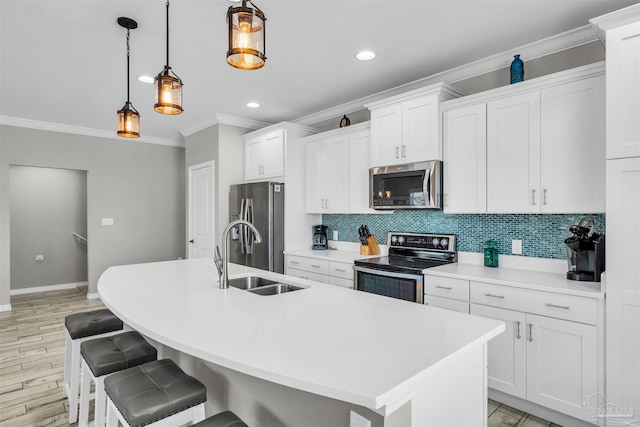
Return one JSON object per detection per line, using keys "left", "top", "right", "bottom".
{"left": 291, "top": 25, "right": 598, "bottom": 126}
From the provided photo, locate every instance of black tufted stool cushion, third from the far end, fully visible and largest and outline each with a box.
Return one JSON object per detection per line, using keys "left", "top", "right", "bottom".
{"left": 104, "top": 359, "right": 207, "bottom": 427}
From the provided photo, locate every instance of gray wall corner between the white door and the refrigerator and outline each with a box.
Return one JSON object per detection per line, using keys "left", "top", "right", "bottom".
{"left": 185, "top": 124, "right": 250, "bottom": 249}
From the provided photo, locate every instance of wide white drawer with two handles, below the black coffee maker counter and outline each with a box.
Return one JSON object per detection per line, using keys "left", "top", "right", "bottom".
{"left": 471, "top": 282, "right": 598, "bottom": 325}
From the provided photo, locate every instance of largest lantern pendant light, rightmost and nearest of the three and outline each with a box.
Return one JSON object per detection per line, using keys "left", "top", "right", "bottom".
{"left": 227, "top": 0, "right": 267, "bottom": 70}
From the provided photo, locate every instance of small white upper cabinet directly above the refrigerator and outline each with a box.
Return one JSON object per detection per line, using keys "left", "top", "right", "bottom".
{"left": 244, "top": 130, "right": 284, "bottom": 181}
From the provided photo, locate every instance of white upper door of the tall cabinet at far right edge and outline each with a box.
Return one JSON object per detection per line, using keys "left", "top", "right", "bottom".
{"left": 606, "top": 22, "right": 640, "bottom": 159}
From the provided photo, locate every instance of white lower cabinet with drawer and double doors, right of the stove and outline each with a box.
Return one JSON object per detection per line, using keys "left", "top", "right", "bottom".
{"left": 470, "top": 282, "right": 602, "bottom": 420}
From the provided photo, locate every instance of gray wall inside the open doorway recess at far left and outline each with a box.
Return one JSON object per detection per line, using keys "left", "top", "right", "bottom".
{"left": 9, "top": 166, "right": 87, "bottom": 289}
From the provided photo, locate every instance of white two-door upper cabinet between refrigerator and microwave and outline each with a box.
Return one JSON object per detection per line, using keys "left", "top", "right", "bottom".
{"left": 304, "top": 123, "right": 375, "bottom": 214}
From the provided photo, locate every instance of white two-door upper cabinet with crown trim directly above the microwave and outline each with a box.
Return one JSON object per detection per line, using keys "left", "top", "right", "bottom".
{"left": 367, "top": 83, "right": 462, "bottom": 166}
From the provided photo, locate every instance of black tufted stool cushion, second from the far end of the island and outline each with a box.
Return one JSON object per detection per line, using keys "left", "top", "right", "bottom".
{"left": 80, "top": 331, "right": 158, "bottom": 377}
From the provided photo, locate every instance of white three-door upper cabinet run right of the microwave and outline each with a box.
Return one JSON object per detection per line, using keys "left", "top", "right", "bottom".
{"left": 442, "top": 63, "right": 605, "bottom": 213}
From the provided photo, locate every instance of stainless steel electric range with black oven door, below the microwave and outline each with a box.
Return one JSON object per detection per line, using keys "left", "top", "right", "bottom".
{"left": 353, "top": 231, "right": 458, "bottom": 304}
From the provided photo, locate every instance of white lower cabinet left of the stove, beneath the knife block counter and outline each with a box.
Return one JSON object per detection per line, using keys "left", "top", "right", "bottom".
{"left": 285, "top": 255, "right": 353, "bottom": 288}
